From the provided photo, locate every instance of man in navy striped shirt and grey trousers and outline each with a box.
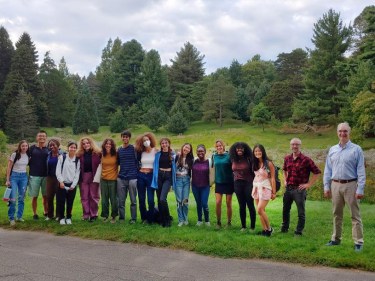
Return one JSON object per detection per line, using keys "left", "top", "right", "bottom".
{"left": 117, "top": 130, "right": 138, "bottom": 224}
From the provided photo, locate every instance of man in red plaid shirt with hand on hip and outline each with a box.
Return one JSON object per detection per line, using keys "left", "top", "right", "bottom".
{"left": 281, "top": 138, "right": 321, "bottom": 236}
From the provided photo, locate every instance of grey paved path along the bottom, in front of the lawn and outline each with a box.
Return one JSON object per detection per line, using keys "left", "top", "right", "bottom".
{"left": 0, "top": 229, "right": 375, "bottom": 281}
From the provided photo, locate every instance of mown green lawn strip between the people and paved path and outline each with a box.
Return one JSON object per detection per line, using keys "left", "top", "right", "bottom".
{"left": 0, "top": 188, "right": 375, "bottom": 271}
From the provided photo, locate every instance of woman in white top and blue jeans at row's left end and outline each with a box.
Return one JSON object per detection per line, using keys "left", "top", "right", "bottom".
{"left": 5, "top": 140, "right": 29, "bottom": 226}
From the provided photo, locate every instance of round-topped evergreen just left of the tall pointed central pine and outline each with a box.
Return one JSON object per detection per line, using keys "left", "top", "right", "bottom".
{"left": 137, "top": 50, "right": 170, "bottom": 112}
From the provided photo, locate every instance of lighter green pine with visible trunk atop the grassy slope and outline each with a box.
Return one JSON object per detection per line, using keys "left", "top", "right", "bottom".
{"left": 203, "top": 76, "right": 235, "bottom": 127}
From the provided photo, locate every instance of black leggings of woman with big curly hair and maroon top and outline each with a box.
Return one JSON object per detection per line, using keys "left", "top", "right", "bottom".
{"left": 234, "top": 180, "right": 256, "bottom": 229}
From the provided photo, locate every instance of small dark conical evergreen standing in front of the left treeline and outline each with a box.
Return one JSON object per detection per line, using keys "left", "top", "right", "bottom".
{"left": 72, "top": 81, "right": 100, "bottom": 134}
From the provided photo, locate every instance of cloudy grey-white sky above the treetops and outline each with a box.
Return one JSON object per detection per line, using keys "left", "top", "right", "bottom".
{"left": 0, "top": 0, "right": 374, "bottom": 75}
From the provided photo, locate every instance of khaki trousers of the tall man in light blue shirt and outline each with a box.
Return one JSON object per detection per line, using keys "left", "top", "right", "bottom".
{"left": 331, "top": 181, "right": 363, "bottom": 244}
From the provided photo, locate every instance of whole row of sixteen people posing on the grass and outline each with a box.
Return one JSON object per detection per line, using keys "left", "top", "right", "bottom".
{"left": 2, "top": 123, "right": 366, "bottom": 251}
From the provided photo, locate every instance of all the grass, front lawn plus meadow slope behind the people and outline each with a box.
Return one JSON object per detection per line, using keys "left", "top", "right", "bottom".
{"left": 0, "top": 122, "right": 375, "bottom": 271}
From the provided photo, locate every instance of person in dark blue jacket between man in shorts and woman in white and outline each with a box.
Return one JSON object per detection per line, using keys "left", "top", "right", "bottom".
{"left": 46, "top": 139, "right": 62, "bottom": 221}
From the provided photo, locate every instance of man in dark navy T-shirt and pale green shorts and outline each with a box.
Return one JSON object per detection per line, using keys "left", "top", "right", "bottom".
{"left": 29, "top": 130, "right": 48, "bottom": 220}
